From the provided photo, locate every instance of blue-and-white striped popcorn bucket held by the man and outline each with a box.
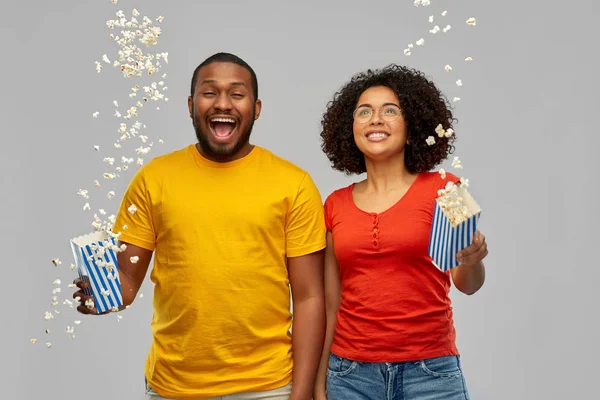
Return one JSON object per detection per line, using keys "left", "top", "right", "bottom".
{"left": 71, "top": 231, "right": 123, "bottom": 313}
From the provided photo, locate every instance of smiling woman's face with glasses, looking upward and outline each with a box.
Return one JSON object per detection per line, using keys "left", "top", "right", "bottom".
{"left": 353, "top": 86, "right": 408, "bottom": 161}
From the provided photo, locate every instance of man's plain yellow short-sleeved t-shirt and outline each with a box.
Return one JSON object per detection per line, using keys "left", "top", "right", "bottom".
{"left": 113, "top": 145, "right": 326, "bottom": 399}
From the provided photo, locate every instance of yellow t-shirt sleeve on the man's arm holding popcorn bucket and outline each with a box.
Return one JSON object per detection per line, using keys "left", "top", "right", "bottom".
{"left": 112, "top": 168, "right": 156, "bottom": 250}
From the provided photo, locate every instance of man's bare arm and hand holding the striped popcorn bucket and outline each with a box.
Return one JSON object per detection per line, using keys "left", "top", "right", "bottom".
{"left": 73, "top": 242, "right": 152, "bottom": 315}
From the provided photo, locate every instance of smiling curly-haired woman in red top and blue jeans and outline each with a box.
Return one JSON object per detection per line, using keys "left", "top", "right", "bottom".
{"left": 315, "top": 65, "right": 488, "bottom": 400}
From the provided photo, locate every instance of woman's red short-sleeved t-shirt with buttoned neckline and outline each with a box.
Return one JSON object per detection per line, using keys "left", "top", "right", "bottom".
{"left": 325, "top": 172, "right": 458, "bottom": 362}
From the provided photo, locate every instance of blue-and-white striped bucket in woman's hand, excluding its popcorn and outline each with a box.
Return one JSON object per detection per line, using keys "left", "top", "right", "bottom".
{"left": 428, "top": 187, "right": 481, "bottom": 272}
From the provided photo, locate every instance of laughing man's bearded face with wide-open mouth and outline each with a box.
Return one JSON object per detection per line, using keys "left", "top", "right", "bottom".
{"left": 188, "top": 62, "right": 261, "bottom": 162}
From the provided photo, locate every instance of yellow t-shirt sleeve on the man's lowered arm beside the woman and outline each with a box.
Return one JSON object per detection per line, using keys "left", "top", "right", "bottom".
{"left": 285, "top": 173, "right": 326, "bottom": 257}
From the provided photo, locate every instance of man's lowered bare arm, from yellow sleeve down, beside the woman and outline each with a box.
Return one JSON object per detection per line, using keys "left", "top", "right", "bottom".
{"left": 288, "top": 250, "right": 325, "bottom": 400}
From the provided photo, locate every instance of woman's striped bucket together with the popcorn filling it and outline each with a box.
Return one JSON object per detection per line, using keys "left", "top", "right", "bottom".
{"left": 428, "top": 182, "right": 481, "bottom": 272}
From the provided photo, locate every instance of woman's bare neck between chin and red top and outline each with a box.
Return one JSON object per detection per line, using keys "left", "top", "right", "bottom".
{"left": 365, "top": 153, "right": 417, "bottom": 192}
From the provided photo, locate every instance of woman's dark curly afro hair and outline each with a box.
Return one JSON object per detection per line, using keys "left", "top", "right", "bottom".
{"left": 321, "top": 64, "right": 456, "bottom": 175}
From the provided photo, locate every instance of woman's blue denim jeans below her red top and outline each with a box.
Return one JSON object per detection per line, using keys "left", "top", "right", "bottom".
{"left": 327, "top": 354, "right": 469, "bottom": 400}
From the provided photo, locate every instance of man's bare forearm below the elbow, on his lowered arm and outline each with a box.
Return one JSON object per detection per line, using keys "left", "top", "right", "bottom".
{"left": 290, "top": 296, "right": 325, "bottom": 400}
